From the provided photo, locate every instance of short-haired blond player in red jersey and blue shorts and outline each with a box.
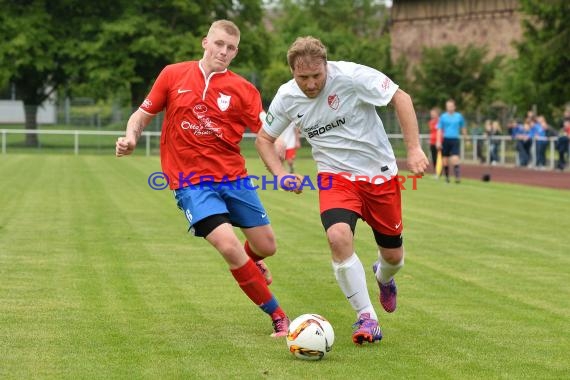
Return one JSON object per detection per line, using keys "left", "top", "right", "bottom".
{"left": 115, "top": 20, "right": 289, "bottom": 337}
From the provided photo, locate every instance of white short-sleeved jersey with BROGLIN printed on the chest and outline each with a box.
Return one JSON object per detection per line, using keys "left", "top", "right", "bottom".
{"left": 263, "top": 61, "right": 398, "bottom": 180}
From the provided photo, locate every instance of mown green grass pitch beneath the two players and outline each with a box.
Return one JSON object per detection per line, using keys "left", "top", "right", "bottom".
{"left": 0, "top": 150, "right": 570, "bottom": 380}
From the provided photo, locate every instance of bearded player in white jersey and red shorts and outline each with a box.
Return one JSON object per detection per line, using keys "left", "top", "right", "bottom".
{"left": 256, "top": 37, "right": 429, "bottom": 344}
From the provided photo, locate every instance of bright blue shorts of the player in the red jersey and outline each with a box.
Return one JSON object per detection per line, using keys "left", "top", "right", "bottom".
{"left": 174, "top": 178, "right": 269, "bottom": 232}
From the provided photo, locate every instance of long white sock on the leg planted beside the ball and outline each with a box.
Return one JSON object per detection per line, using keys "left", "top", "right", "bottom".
{"left": 333, "top": 253, "right": 378, "bottom": 320}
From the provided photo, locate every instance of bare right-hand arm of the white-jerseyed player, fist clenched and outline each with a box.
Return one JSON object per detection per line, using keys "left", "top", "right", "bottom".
{"left": 391, "top": 89, "right": 429, "bottom": 175}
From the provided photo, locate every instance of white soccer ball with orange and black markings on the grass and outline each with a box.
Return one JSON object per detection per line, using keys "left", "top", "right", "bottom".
{"left": 287, "top": 314, "right": 334, "bottom": 360}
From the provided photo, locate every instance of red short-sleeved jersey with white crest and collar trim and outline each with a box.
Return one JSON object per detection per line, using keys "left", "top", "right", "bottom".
{"left": 139, "top": 61, "right": 263, "bottom": 190}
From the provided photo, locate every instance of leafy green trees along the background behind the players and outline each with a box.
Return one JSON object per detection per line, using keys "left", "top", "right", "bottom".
{"left": 0, "top": 0, "right": 570, "bottom": 145}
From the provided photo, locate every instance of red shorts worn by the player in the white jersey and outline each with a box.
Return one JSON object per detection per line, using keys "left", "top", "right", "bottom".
{"left": 319, "top": 173, "right": 403, "bottom": 236}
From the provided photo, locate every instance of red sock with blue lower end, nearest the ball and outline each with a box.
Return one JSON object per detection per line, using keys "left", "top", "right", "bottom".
{"left": 231, "top": 260, "right": 285, "bottom": 315}
